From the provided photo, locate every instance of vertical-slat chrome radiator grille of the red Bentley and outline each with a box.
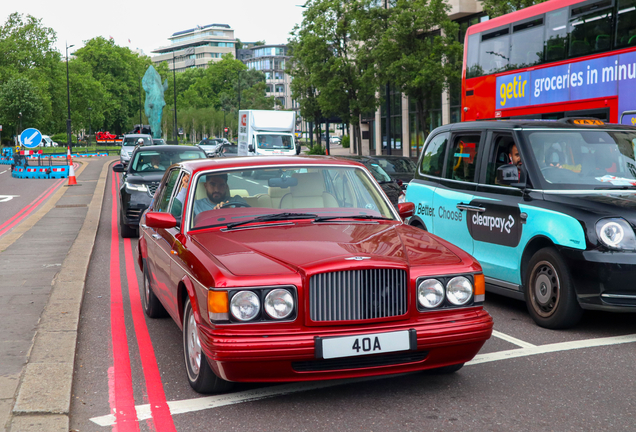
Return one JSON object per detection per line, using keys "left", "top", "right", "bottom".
{"left": 309, "top": 269, "right": 407, "bottom": 321}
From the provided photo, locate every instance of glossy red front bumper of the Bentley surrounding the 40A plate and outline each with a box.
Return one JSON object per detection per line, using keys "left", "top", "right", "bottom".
{"left": 199, "top": 310, "right": 493, "bottom": 382}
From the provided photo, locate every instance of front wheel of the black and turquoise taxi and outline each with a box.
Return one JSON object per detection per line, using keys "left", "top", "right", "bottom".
{"left": 524, "top": 247, "right": 583, "bottom": 330}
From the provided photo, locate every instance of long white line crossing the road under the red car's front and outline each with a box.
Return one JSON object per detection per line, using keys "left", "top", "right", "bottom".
{"left": 90, "top": 334, "right": 636, "bottom": 426}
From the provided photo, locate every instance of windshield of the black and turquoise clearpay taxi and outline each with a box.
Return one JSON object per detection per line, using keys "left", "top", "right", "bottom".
{"left": 526, "top": 130, "right": 636, "bottom": 189}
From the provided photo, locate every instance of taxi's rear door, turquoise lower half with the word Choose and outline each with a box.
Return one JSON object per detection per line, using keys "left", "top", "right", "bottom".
{"left": 433, "top": 131, "right": 483, "bottom": 254}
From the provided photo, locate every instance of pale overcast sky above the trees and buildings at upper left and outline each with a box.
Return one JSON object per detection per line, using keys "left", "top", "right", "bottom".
{"left": 0, "top": 0, "right": 304, "bottom": 56}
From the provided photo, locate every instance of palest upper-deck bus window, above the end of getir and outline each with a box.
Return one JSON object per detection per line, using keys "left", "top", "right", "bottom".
{"left": 510, "top": 18, "right": 543, "bottom": 68}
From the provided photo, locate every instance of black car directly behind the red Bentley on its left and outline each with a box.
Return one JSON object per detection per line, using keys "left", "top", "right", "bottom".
{"left": 113, "top": 145, "right": 206, "bottom": 238}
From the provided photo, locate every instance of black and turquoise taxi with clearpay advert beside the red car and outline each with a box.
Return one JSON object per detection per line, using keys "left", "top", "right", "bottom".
{"left": 406, "top": 118, "right": 636, "bottom": 329}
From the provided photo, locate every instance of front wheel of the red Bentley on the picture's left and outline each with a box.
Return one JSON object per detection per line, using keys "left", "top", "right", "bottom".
{"left": 183, "top": 299, "right": 232, "bottom": 393}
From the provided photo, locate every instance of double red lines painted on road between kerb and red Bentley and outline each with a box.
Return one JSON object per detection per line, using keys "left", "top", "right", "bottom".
{"left": 109, "top": 171, "right": 176, "bottom": 432}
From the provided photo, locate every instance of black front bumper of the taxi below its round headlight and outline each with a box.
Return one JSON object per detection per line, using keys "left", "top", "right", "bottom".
{"left": 562, "top": 249, "right": 636, "bottom": 312}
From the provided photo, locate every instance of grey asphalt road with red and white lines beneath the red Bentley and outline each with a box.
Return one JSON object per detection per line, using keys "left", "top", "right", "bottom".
{"left": 69, "top": 167, "right": 636, "bottom": 432}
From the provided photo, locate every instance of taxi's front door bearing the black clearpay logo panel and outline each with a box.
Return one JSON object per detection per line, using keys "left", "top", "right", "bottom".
{"left": 468, "top": 131, "right": 530, "bottom": 291}
